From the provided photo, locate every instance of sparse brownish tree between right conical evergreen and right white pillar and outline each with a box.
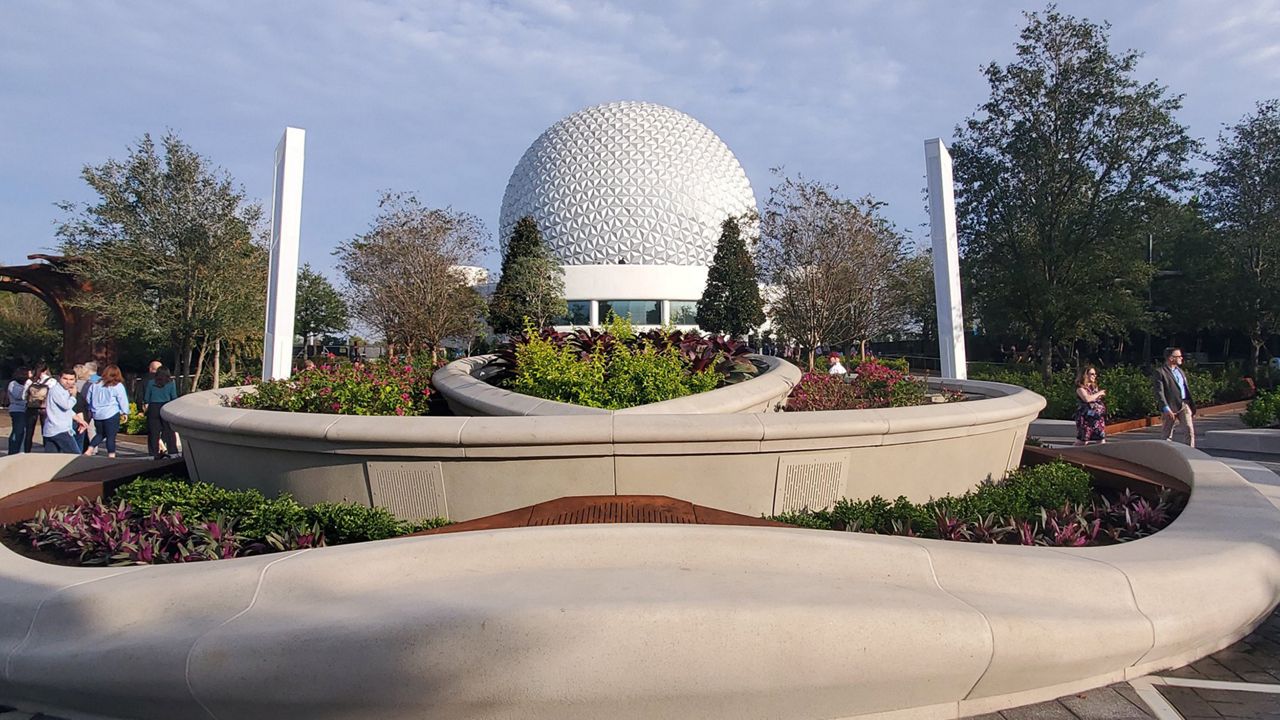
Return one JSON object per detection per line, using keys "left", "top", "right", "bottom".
{"left": 756, "top": 170, "right": 905, "bottom": 370}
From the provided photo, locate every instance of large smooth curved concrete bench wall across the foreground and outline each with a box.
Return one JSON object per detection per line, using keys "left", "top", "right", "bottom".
{"left": 0, "top": 442, "right": 1280, "bottom": 720}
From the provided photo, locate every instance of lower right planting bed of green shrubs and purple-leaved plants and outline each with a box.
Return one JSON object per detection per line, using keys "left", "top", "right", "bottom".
{"left": 771, "top": 461, "right": 1187, "bottom": 547}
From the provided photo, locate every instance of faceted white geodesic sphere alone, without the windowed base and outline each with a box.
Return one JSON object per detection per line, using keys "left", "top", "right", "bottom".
{"left": 499, "top": 101, "right": 756, "bottom": 265}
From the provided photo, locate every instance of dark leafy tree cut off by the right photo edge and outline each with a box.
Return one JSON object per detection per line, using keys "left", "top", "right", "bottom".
{"left": 1203, "top": 100, "right": 1280, "bottom": 366}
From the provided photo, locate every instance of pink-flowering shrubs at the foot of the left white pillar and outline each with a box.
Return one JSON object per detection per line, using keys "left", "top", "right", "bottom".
{"left": 228, "top": 355, "right": 435, "bottom": 415}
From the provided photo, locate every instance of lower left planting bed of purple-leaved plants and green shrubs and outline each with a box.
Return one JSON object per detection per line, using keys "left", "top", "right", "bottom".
{"left": 0, "top": 475, "right": 447, "bottom": 565}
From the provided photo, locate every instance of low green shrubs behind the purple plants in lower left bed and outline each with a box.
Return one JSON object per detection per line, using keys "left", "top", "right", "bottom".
{"left": 113, "top": 475, "right": 448, "bottom": 544}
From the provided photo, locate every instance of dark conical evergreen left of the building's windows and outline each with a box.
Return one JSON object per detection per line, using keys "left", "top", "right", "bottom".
{"left": 489, "top": 215, "right": 568, "bottom": 334}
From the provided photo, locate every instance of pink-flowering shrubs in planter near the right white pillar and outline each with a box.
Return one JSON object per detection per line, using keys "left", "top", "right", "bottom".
{"left": 785, "top": 359, "right": 927, "bottom": 413}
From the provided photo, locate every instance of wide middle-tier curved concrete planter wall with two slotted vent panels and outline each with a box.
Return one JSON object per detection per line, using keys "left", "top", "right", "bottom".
{"left": 164, "top": 380, "right": 1044, "bottom": 520}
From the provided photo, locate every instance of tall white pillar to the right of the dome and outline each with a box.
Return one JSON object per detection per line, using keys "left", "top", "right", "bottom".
{"left": 924, "top": 137, "right": 969, "bottom": 380}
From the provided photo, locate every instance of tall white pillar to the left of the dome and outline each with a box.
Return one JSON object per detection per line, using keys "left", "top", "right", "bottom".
{"left": 262, "top": 128, "right": 306, "bottom": 379}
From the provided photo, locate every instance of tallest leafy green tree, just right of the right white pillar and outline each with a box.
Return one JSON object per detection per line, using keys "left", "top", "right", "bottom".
{"left": 952, "top": 5, "right": 1196, "bottom": 378}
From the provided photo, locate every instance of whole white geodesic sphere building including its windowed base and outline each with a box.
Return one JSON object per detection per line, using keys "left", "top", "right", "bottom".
{"left": 499, "top": 101, "right": 756, "bottom": 327}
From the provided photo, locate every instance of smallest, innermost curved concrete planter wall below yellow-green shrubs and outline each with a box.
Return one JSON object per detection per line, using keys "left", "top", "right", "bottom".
{"left": 431, "top": 355, "right": 803, "bottom": 416}
